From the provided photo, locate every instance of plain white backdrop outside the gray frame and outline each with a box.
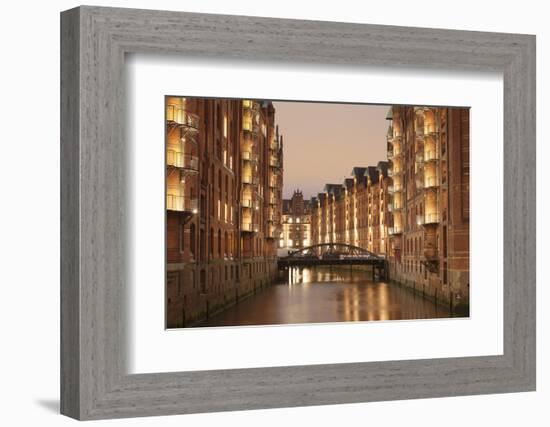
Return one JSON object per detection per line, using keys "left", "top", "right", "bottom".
{"left": 0, "top": 0, "right": 550, "bottom": 426}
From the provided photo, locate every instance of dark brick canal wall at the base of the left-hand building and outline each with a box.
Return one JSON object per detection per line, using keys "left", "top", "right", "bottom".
{"left": 166, "top": 257, "right": 278, "bottom": 328}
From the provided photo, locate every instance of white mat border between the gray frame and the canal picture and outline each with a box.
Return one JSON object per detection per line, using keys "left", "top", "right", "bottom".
{"left": 126, "top": 55, "right": 503, "bottom": 373}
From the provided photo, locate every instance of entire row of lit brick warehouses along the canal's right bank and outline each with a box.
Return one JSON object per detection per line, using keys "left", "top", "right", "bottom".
{"left": 311, "top": 106, "right": 470, "bottom": 313}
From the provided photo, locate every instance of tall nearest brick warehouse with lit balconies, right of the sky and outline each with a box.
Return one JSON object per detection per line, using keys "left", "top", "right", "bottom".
{"left": 388, "top": 106, "right": 470, "bottom": 311}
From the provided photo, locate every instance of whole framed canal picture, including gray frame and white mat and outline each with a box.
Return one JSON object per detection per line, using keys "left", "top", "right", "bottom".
{"left": 61, "top": 6, "right": 536, "bottom": 420}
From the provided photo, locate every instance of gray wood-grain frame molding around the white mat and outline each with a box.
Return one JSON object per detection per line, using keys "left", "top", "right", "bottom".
{"left": 61, "top": 6, "right": 536, "bottom": 419}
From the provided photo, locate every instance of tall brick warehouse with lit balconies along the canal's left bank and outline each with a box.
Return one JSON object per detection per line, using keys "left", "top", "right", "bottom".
{"left": 166, "top": 97, "right": 283, "bottom": 328}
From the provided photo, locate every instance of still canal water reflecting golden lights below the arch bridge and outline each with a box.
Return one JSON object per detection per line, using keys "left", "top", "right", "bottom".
{"left": 198, "top": 267, "right": 451, "bottom": 326}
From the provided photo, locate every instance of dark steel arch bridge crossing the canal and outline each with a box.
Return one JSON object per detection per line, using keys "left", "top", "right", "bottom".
{"left": 277, "top": 243, "right": 389, "bottom": 279}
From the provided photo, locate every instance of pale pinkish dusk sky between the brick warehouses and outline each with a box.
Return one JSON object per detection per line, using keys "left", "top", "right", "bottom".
{"left": 273, "top": 102, "right": 389, "bottom": 199}
